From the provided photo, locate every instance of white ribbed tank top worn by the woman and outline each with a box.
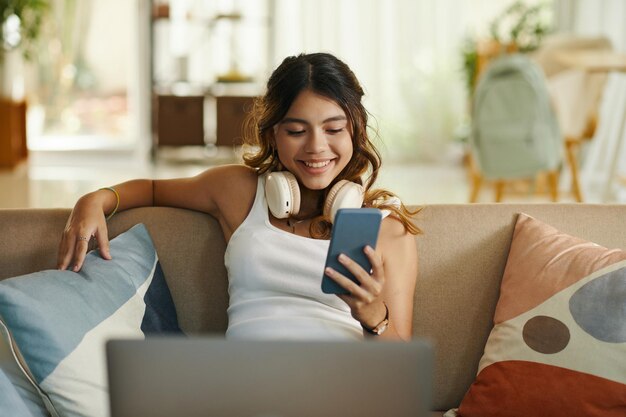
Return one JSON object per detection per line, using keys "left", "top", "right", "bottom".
{"left": 224, "top": 176, "right": 363, "bottom": 340}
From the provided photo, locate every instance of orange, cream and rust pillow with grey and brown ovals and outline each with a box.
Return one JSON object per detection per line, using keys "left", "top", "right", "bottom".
{"left": 458, "top": 214, "right": 626, "bottom": 417}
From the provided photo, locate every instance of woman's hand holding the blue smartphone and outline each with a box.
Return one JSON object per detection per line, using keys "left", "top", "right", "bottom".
{"left": 325, "top": 245, "right": 386, "bottom": 329}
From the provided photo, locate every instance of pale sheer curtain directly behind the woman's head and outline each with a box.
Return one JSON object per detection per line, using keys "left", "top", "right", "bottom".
{"left": 270, "top": 0, "right": 536, "bottom": 162}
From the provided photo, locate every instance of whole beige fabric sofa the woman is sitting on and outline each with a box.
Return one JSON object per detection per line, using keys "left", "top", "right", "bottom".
{"left": 0, "top": 204, "right": 626, "bottom": 415}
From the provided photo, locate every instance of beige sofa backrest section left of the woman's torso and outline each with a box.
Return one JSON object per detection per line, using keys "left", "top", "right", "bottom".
{"left": 0, "top": 207, "right": 228, "bottom": 333}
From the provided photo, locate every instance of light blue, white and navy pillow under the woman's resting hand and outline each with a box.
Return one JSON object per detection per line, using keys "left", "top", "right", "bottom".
{"left": 0, "top": 224, "right": 181, "bottom": 417}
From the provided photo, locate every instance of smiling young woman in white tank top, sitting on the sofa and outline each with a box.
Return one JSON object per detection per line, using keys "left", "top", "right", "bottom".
{"left": 58, "top": 53, "right": 418, "bottom": 340}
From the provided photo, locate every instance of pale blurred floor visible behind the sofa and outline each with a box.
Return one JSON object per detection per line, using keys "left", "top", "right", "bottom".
{"left": 0, "top": 149, "right": 572, "bottom": 208}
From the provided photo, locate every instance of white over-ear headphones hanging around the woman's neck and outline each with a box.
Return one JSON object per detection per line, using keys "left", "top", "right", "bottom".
{"left": 265, "top": 171, "right": 364, "bottom": 223}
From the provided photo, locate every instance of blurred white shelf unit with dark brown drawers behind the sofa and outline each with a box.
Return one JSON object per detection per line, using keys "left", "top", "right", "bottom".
{"left": 148, "top": 0, "right": 272, "bottom": 156}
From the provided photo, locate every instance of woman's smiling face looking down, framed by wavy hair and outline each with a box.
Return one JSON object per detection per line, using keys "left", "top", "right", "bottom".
{"left": 274, "top": 90, "right": 353, "bottom": 190}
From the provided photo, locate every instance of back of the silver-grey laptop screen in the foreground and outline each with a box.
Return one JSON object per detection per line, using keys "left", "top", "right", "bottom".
{"left": 107, "top": 337, "right": 433, "bottom": 417}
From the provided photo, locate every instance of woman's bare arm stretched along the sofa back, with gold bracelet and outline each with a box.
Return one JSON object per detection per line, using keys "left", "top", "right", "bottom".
{"left": 57, "top": 165, "right": 257, "bottom": 271}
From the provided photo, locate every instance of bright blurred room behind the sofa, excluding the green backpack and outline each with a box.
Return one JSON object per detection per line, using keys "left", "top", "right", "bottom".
{"left": 0, "top": 0, "right": 626, "bottom": 208}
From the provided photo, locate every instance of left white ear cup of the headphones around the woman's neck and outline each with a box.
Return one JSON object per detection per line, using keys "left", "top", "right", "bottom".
{"left": 265, "top": 171, "right": 300, "bottom": 219}
